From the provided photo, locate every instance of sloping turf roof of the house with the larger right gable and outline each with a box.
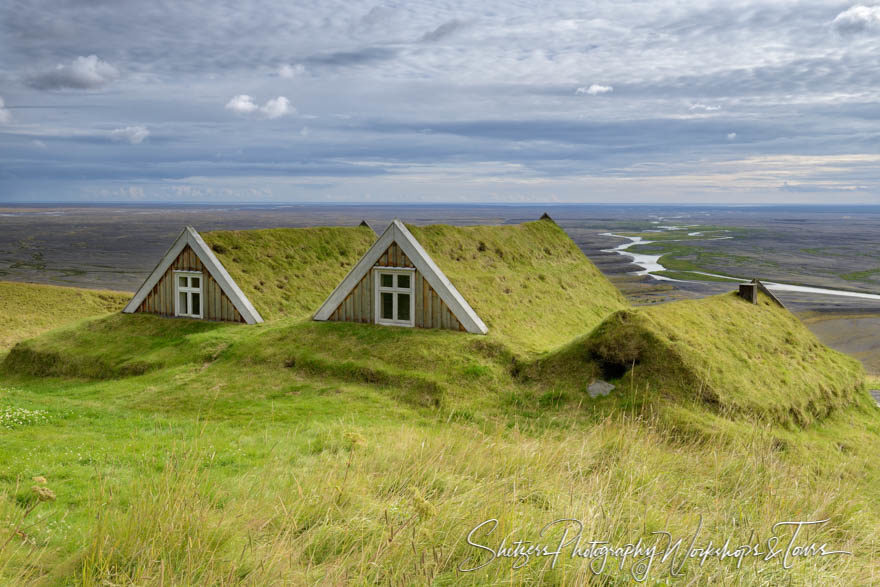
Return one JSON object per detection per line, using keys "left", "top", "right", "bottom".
{"left": 407, "top": 220, "right": 628, "bottom": 353}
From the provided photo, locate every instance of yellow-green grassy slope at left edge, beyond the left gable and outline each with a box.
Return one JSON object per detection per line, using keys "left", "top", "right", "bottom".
{"left": 0, "top": 281, "right": 131, "bottom": 354}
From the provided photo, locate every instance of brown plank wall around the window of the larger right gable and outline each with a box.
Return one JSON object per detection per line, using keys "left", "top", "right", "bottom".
{"left": 330, "top": 243, "right": 464, "bottom": 331}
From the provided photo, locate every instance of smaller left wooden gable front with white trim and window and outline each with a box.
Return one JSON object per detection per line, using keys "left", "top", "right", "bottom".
{"left": 122, "top": 226, "right": 263, "bottom": 324}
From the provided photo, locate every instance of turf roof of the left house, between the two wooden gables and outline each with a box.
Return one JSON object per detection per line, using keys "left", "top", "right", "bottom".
{"left": 202, "top": 226, "right": 376, "bottom": 320}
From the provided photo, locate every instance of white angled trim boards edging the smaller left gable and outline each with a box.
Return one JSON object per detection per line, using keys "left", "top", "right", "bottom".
{"left": 122, "top": 226, "right": 263, "bottom": 324}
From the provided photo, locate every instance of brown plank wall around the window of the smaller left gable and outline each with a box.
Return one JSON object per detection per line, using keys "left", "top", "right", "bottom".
{"left": 137, "top": 245, "right": 244, "bottom": 322}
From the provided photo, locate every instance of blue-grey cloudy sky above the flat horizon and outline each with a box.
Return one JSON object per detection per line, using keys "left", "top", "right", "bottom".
{"left": 0, "top": 0, "right": 880, "bottom": 203}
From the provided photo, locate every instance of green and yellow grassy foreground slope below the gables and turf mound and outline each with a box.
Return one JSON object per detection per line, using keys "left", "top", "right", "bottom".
{"left": 0, "top": 324, "right": 880, "bottom": 585}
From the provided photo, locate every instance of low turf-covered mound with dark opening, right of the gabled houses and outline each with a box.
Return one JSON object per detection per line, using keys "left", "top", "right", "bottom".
{"left": 532, "top": 293, "right": 865, "bottom": 425}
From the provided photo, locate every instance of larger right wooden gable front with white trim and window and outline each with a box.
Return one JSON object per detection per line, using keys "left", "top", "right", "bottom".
{"left": 314, "top": 219, "right": 488, "bottom": 334}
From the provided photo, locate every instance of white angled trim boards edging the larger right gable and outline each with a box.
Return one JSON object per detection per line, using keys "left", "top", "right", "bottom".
{"left": 314, "top": 219, "right": 489, "bottom": 334}
